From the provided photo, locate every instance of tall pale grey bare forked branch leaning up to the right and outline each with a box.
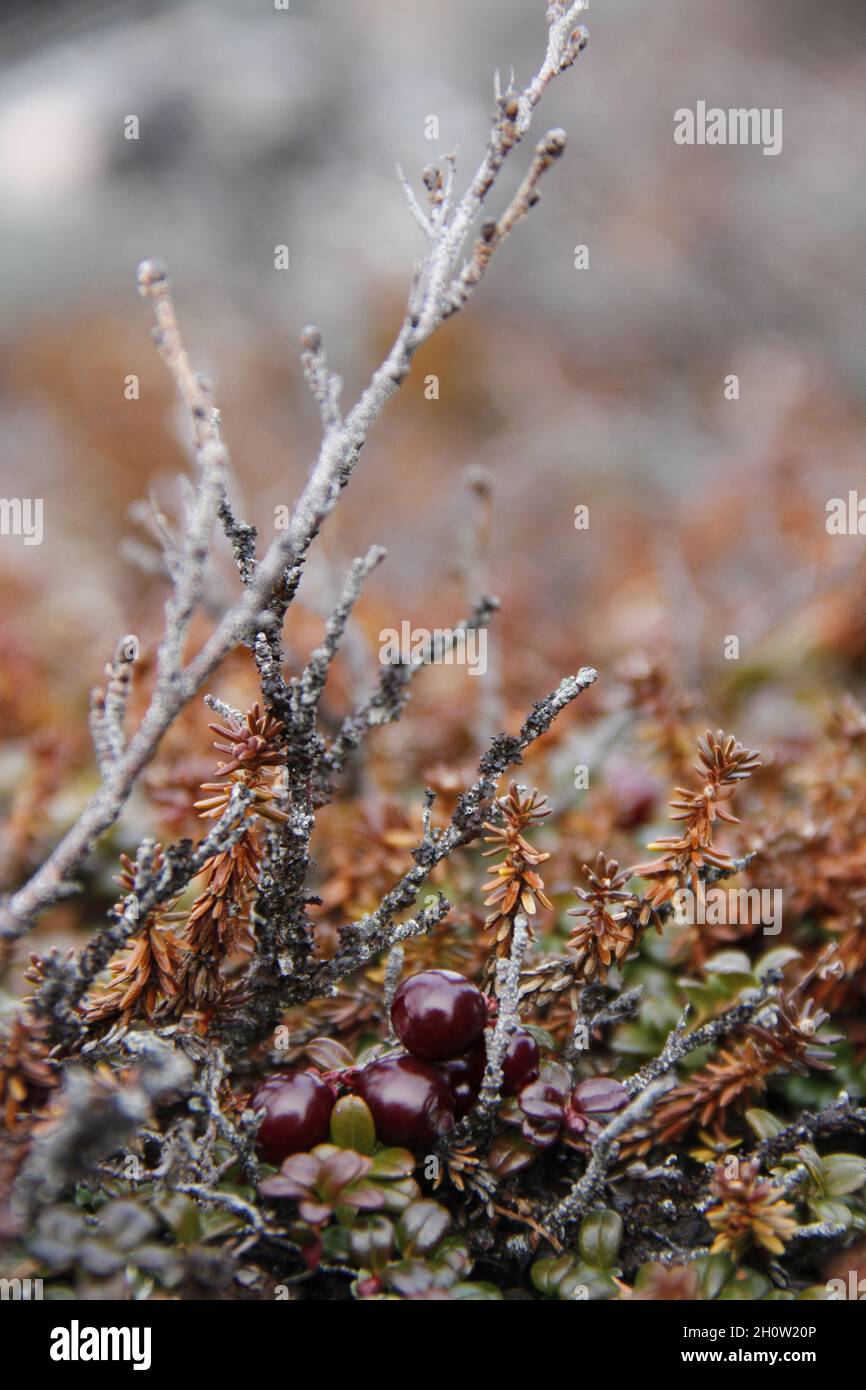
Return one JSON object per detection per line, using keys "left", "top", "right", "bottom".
{"left": 0, "top": 0, "right": 585, "bottom": 937}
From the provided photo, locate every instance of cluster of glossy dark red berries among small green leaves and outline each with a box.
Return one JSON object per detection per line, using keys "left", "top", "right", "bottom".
{"left": 252, "top": 970, "right": 539, "bottom": 1163}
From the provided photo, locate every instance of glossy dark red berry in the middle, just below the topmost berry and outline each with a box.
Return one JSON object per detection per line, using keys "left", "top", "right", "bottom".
{"left": 354, "top": 1054, "right": 455, "bottom": 1150}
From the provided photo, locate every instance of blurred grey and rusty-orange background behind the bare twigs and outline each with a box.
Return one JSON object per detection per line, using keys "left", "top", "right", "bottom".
{"left": 0, "top": 0, "right": 866, "bottom": 945}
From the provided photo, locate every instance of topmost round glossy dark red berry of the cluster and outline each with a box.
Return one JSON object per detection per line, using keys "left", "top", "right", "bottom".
{"left": 391, "top": 970, "right": 487, "bottom": 1062}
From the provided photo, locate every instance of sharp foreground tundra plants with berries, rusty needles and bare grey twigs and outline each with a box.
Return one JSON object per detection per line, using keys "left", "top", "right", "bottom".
{"left": 0, "top": 0, "right": 866, "bottom": 1301}
